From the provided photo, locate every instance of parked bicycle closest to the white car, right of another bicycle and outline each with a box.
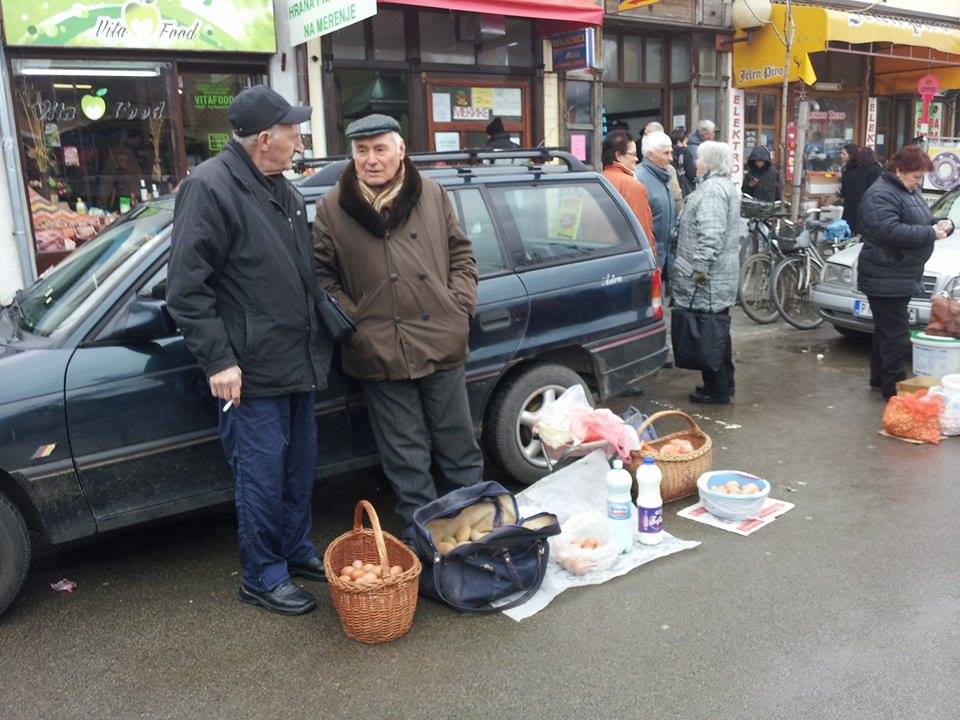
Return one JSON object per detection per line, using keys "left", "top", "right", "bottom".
{"left": 771, "top": 215, "right": 853, "bottom": 330}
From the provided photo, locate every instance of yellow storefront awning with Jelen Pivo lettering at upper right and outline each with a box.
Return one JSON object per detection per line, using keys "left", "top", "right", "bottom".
{"left": 733, "top": 5, "right": 960, "bottom": 92}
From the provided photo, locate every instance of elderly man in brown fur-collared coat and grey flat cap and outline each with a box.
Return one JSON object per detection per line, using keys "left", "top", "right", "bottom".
{"left": 313, "top": 115, "right": 483, "bottom": 524}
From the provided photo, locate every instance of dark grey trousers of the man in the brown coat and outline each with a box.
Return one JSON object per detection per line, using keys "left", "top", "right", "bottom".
{"left": 360, "top": 365, "right": 483, "bottom": 525}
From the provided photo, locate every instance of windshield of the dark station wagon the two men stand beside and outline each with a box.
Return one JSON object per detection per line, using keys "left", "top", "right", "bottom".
{"left": 17, "top": 201, "right": 173, "bottom": 335}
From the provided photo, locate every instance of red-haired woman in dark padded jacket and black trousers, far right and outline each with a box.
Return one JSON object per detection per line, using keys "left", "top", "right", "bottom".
{"left": 857, "top": 145, "right": 953, "bottom": 398}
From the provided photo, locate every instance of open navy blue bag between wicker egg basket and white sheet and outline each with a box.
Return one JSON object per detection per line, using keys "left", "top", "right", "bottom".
{"left": 404, "top": 482, "right": 560, "bottom": 613}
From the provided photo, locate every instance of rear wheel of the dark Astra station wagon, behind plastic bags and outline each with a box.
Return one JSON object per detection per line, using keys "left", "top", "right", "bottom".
{"left": 484, "top": 363, "right": 590, "bottom": 485}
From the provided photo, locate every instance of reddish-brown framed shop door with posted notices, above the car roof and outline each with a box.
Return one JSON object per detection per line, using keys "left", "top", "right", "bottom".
{"left": 427, "top": 77, "right": 532, "bottom": 152}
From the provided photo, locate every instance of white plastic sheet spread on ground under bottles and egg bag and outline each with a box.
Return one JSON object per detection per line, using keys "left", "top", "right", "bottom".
{"left": 503, "top": 450, "right": 700, "bottom": 622}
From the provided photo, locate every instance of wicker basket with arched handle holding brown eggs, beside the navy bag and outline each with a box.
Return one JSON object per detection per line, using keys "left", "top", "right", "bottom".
{"left": 323, "top": 500, "right": 421, "bottom": 643}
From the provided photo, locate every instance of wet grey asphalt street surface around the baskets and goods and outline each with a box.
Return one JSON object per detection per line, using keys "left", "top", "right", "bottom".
{"left": 0, "top": 313, "right": 960, "bottom": 720}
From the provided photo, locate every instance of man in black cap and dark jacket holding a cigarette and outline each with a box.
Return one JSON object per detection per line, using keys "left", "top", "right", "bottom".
{"left": 167, "top": 85, "right": 332, "bottom": 615}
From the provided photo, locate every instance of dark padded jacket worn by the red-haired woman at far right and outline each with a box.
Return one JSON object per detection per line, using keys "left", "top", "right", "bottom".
{"left": 857, "top": 172, "right": 936, "bottom": 297}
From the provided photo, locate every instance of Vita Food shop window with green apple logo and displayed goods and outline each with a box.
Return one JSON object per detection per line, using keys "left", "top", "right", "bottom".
{"left": 12, "top": 59, "right": 179, "bottom": 264}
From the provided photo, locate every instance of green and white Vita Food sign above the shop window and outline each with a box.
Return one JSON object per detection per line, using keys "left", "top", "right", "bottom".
{"left": 2, "top": 0, "right": 277, "bottom": 53}
